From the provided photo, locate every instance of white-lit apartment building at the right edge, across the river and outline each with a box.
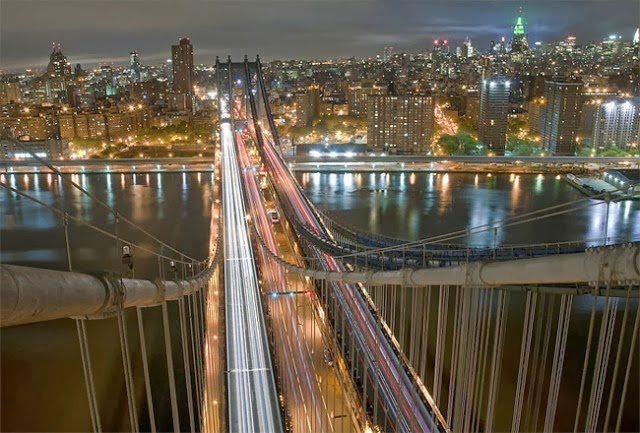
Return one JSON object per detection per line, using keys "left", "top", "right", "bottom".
{"left": 593, "top": 98, "right": 640, "bottom": 149}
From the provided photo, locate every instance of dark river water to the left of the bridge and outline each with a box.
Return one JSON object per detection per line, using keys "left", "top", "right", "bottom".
{"left": 0, "top": 172, "right": 213, "bottom": 431}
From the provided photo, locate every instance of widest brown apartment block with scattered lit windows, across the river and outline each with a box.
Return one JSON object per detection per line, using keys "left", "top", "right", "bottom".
{"left": 367, "top": 95, "right": 434, "bottom": 154}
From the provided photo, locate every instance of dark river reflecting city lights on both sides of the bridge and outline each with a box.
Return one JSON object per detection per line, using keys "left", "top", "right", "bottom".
{"left": 0, "top": 172, "right": 640, "bottom": 431}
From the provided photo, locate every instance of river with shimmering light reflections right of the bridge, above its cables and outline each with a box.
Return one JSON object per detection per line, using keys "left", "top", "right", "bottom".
{"left": 296, "top": 172, "right": 640, "bottom": 246}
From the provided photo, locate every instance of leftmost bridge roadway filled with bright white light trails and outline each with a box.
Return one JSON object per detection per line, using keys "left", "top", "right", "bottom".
{"left": 220, "top": 97, "right": 284, "bottom": 433}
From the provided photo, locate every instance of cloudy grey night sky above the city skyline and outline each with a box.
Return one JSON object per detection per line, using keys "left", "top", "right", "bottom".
{"left": 0, "top": 0, "right": 640, "bottom": 71}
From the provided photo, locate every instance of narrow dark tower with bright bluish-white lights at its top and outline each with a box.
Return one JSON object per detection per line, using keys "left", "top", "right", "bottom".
{"left": 478, "top": 76, "right": 511, "bottom": 155}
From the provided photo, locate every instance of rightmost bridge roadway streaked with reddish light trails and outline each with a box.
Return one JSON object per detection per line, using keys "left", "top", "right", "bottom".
{"left": 247, "top": 60, "right": 445, "bottom": 432}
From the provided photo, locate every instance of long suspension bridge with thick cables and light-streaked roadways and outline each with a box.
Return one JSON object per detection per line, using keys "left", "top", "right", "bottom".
{"left": 0, "top": 58, "right": 640, "bottom": 432}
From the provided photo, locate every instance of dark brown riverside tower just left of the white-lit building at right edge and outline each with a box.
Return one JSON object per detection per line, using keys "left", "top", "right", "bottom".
{"left": 542, "top": 79, "right": 584, "bottom": 155}
